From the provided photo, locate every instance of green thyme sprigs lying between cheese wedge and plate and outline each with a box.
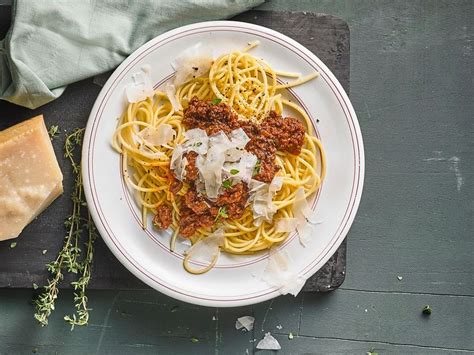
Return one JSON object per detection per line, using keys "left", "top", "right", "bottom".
{"left": 34, "top": 129, "right": 97, "bottom": 330}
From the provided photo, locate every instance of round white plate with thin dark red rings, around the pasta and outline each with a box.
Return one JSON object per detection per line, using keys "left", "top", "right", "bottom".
{"left": 82, "top": 21, "right": 364, "bottom": 307}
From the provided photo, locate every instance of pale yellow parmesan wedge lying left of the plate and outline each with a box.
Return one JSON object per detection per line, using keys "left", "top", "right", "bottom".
{"left": 0, "top": 116, "right": 63, "bottom": 241}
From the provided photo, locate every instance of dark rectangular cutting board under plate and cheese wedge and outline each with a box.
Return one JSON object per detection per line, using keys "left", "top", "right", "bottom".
{"left": 0, "top": 6, "right": 350, "bottom": 292}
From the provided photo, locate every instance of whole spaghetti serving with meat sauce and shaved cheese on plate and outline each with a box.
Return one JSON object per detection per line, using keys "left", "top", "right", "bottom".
{"left": 113, "top": 43, "right": 325, "bottom": 274}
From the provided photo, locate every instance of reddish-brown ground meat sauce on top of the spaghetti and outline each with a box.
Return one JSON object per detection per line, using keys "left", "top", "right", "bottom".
{"left": 174, "top": 97, "right": 305, "bottom": 237}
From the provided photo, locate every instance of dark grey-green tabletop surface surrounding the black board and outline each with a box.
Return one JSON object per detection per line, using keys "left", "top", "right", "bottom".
{"left": 0, "top": 0, "right": 474, "bottom": 354}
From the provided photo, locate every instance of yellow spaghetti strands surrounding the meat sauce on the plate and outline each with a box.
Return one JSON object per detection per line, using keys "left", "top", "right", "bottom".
{"left": 113, "top": 43, "right": 326, "bottom": 274}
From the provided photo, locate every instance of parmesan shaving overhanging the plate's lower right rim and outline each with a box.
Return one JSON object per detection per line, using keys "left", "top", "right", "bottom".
{"left": 262, "top": 249, "right": 306, "bottom": 297}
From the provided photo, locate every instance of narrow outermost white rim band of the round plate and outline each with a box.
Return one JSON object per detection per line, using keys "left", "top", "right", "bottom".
{"left": 81, "top": 21, "right": 365, "bottom": 307}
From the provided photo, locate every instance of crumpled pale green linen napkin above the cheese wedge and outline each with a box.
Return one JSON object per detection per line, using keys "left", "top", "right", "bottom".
{"left": 0, "top": 0, "right": 264, "bottom": 108}
